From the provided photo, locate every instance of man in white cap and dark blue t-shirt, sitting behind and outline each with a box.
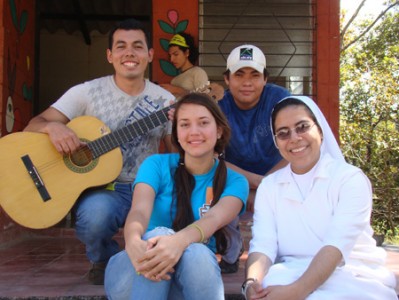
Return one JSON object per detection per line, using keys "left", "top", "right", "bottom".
{"left": 218, "top": 45, "right": 290, "bottom": 273}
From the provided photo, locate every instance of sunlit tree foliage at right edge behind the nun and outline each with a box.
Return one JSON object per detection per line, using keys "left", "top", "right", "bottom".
{"left": 340, "top": 9, "right": 399, "bottom": 236}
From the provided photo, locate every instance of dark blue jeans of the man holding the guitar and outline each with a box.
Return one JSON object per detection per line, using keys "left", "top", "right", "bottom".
{"left": 75, "top": 183, "right": 132, "bottom": 263}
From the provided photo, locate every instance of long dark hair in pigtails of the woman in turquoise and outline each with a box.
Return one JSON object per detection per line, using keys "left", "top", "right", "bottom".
{"left": 172, "top": 93, "right": 231, "bottom": 254}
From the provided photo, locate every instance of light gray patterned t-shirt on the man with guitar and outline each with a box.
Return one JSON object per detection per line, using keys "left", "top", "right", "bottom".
{"left": 52, "top": 75, "right": 174, "bottom": 182}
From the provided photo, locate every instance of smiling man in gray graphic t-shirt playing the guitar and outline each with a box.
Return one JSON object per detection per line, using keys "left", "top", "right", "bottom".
{"left": 25, "top": 19, "right": 174, "bottom": 284}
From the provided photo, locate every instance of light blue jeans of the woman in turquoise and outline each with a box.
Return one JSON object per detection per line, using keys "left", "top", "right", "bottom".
{"left": 104, "top": 227, "right": 224, "bottom": 300}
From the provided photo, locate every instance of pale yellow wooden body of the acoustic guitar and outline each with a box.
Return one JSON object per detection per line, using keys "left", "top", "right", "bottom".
{"left": 0, "top": 116, "right": 122, "bottom": 229}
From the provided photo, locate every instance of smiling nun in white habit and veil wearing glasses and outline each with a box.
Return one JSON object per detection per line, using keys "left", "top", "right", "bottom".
{"left": 242, "top": 96, "right": 398, "bottom": 300}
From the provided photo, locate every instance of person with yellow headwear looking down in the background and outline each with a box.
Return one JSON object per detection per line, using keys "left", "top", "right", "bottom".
{"left": 161, "top": 32, "right": 208, "bottom": 97}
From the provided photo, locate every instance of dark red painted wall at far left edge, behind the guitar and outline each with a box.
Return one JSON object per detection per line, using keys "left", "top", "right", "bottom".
{"left": 0, "top": 0, "right": 35, "bottom": 243}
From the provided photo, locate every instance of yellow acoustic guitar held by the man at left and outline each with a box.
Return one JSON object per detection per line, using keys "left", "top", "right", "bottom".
{"left": 0, "top": 86, "right": 223, "bottom": 229}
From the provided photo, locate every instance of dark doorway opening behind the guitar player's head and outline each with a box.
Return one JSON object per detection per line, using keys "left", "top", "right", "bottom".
{"left": 34, "top": 0, "right": 152, "bottom": 115}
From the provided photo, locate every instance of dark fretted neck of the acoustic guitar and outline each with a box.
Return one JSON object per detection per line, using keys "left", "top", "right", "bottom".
{"left": 87, "top": 105, "right": 173, "bottom": 159}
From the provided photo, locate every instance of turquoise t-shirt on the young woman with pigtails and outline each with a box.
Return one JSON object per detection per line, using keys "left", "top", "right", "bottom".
{"left": 134, "top": 153, "right": 249, "bottom": 251}
